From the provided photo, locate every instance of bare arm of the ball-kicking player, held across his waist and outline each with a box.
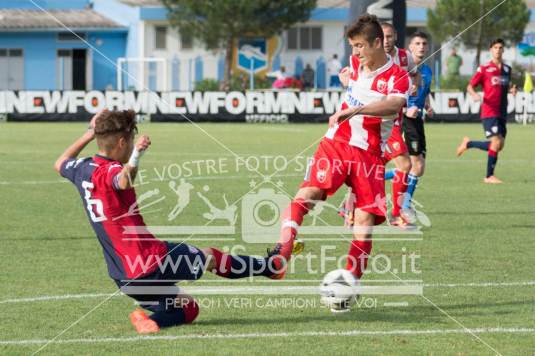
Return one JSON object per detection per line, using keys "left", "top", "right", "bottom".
{"left": 329, "top": 95, "right": 406, "bottom": 127}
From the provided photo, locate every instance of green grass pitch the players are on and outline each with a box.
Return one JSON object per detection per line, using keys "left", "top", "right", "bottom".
{"left": 0, "top": 123, "right": 535, "bottom": 355}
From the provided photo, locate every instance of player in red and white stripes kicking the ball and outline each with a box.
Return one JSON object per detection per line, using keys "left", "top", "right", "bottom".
{"left": 271, "top": 15, "right": 410, "bottom": 290}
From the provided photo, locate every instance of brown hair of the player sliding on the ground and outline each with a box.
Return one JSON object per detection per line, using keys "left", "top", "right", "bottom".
{"left": 95, "top": 110, "right": 137, "bottom": 151}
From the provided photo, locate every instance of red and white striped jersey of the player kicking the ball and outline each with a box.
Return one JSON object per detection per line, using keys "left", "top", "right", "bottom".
{"left": 325, "top": 56, "right": 410, "bottom": 155}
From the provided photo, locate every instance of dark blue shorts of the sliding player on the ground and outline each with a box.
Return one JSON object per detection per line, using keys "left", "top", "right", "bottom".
{"left": 115, "top": 242, "right": 206, "bottom": 312}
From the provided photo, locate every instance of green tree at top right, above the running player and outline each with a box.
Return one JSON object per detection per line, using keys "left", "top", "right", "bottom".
{"left": 427, "top": 0, "right": 530, "bottom": 65}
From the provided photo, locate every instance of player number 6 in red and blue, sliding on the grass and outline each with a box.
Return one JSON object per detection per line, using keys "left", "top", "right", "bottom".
{"left": 54, "top": 111, "right": 282, "bottom": 334}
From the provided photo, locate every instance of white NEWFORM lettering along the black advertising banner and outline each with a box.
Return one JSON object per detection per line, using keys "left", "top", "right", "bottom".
{"left": 0, "top": 90, "right": 535, "bottom": 117}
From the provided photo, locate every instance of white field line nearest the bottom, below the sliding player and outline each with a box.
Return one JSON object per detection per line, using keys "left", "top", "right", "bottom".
{"left": 0, "top": 327, "right": 535, "bottom": 346}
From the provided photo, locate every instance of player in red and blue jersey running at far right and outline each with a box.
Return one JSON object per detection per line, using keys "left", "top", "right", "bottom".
{"left": 457, "top": 38, "right": 516, "bottom": 184}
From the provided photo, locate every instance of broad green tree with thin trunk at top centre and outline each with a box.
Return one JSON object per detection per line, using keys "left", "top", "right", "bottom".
{"left": 162, "top": 0, "right": 317, "bottom": 90}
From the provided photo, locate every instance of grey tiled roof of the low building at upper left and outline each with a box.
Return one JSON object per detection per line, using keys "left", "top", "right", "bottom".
{"left": 0, "top": 9, "right": 123, "bottom": 30}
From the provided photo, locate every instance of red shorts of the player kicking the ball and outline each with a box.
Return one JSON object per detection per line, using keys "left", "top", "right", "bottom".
{"left": 301, "top": 138, "right": 386, "bottom": 225}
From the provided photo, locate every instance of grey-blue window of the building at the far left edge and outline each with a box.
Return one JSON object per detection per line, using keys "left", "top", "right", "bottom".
{"left": 0, "top": 48, "right": 24, "bottom": 90}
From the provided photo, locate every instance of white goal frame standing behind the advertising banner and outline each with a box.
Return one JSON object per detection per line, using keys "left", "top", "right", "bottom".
{"left": 117, "top": 57, "right": 169, "bottom": 91}
